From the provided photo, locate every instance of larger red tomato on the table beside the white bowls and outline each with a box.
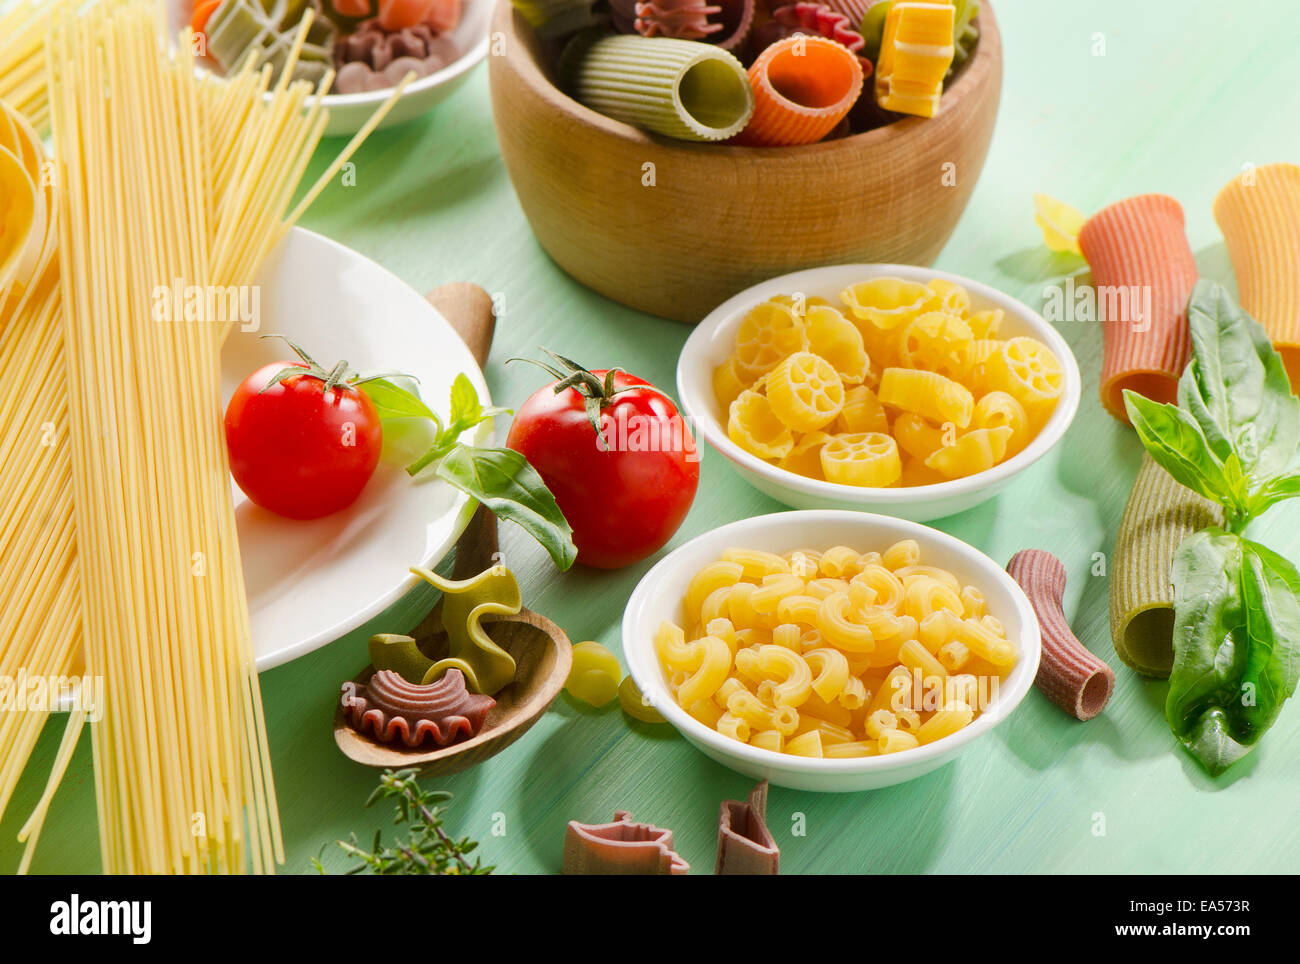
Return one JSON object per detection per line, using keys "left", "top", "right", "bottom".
{"left": 506, "top": 369, "right": 699, "bottom": 569}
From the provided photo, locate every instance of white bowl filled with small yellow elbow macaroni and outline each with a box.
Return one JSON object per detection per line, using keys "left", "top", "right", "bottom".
{"left": 623, "top": 509, "right": 1040, "bottom": 793}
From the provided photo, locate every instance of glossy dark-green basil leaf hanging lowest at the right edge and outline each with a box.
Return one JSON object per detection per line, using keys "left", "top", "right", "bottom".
{"left": 1165, "top": 529, "right": 1300, "bottom": 776}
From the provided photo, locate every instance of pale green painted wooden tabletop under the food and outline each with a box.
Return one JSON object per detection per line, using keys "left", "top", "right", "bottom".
{"left": 0, "top": 0, "right": 1300, "bottom": 873}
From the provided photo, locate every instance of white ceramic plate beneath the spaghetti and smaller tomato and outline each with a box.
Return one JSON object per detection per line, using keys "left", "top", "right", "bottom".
{"left": 221, "top": 229, "right": 491, "bottom": 669}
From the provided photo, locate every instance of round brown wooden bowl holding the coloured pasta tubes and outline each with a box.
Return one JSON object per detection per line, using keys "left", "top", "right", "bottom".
{"left": 488, "top": 0, "right": 1002, "bottom": 323}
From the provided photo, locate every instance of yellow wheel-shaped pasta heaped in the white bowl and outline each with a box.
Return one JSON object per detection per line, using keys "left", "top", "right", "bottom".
{"left": 714, "top": 278, "right": 1063, "bottom": 488}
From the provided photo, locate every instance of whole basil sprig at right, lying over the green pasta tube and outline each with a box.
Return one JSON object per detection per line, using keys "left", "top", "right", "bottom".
{"left": 1125, "top": 281, "right": 1300, "bottom": 776}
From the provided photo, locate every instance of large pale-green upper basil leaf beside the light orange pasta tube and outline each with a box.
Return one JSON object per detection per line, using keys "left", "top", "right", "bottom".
{"left": 1178, "top": 279, "right": 1300, "bottom": 485}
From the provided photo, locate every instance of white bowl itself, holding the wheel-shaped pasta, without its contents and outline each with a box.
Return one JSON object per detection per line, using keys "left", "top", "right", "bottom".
{"left": 677, "top": 265, "right": 1082, "bottom": 522}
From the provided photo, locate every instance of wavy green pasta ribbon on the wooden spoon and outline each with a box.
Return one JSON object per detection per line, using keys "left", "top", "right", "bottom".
{"left": 410, "top": 565, "right": 524, "bottom": 695}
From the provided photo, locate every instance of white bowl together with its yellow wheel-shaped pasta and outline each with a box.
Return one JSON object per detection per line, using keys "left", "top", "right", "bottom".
{"left": 677, "top": 264, "right": 1080, "bottom": 521}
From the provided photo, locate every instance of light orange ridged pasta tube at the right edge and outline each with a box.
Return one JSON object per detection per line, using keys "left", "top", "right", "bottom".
{"left": 1214, "top": 164, "right": 1300, "bottom": 386}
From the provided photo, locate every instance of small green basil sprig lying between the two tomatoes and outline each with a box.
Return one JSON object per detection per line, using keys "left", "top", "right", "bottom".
{"left": 364, "top": 373, "right": 577, "bottom": 569}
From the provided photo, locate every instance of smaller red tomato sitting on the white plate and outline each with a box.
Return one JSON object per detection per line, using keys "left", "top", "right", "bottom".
{"left": 226, "top": 361, "right": 384, "bottom": 518}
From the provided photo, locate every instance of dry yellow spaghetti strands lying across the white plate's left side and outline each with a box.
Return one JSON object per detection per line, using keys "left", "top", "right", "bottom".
{"left": 0, "top": 4, "right": 404, "bottom": 872}
